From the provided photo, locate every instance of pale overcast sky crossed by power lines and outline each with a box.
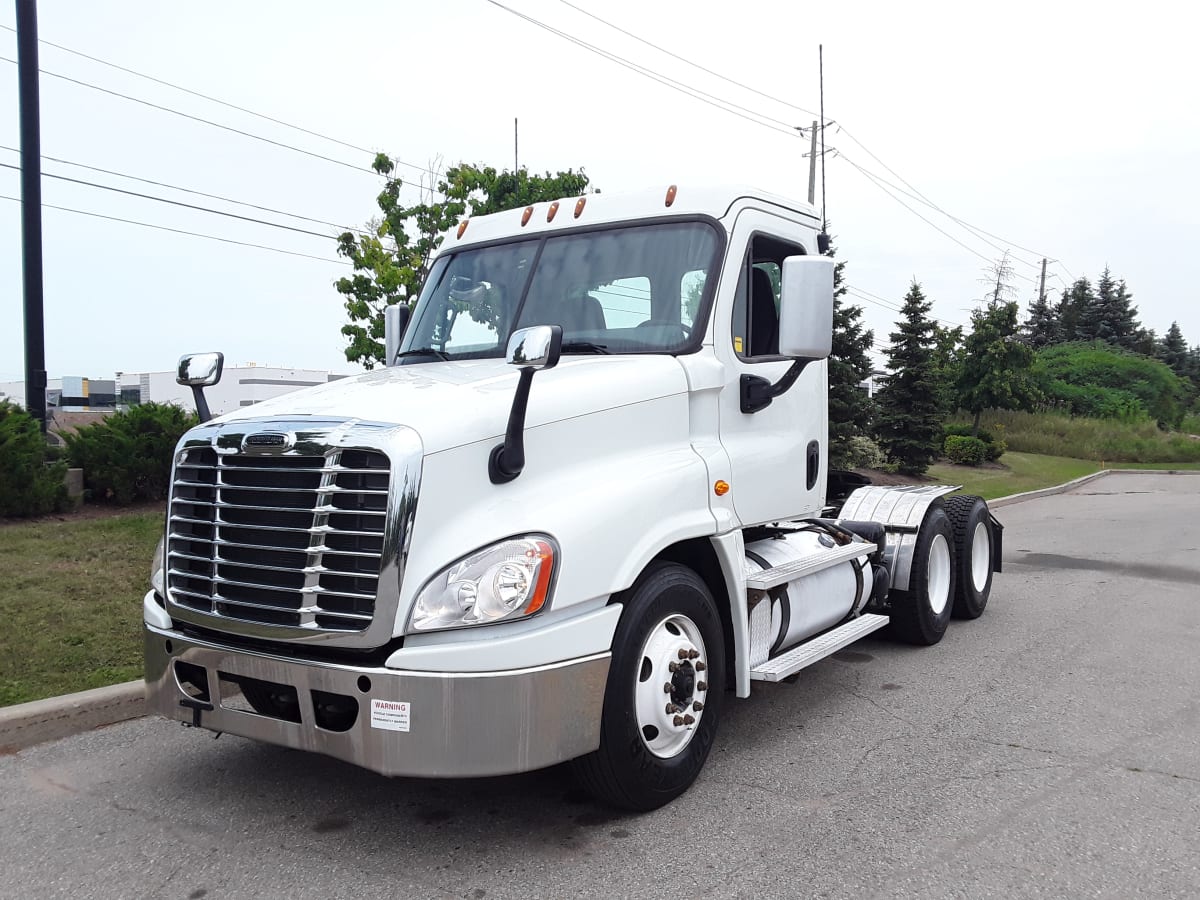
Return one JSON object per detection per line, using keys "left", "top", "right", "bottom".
{"left": 0, "top": 0, "right": 1200, "bottom": 382}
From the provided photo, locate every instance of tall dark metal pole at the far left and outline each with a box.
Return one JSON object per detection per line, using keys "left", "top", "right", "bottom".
{"left": 17, "top": 0, "right": 46, "bottom": 432}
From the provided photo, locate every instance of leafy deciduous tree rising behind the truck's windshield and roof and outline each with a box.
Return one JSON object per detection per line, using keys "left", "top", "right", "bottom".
{"left": 335, "top": 154, "right": 588, "bottom": 368}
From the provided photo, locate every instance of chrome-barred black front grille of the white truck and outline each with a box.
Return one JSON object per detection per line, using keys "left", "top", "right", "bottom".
{"left": 167, "top": 444, "right": 391, "bottom": 631}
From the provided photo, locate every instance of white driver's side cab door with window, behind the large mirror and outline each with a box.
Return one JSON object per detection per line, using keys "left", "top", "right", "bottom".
{"left": 713, "top": 208, "right": 828, "bottom": 526}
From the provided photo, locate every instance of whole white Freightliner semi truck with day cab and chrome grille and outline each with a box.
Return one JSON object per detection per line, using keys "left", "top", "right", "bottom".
{"left": 144, "top": 186, "right": 1001, "bottom": 809}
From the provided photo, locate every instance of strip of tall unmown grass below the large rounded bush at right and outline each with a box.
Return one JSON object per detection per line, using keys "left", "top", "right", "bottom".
{"left": 960, "top": 410, "right": 1200, "bottom": 467}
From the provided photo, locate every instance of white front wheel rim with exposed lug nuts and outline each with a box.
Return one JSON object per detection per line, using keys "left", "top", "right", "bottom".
{"left": 634, "top": 613, "right": 708, "bottom": 760}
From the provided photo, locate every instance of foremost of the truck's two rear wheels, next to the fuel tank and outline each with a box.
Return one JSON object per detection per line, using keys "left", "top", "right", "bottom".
{"left": 889, "top": 502, "right": 955, "bottom": 647}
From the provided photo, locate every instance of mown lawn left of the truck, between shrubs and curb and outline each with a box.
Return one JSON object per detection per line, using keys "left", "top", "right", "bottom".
{"left": 0, "top": 511, "right": 163, "bottom": 706}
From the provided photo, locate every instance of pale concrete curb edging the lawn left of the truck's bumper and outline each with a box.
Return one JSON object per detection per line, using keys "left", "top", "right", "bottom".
{"left": 0, "top": 680, "right": 145, "bottom": 754}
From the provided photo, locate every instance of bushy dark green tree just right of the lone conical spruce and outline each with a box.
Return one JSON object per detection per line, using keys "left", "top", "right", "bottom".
{"left": 958, "top": 302, "right": 1040, "bottom": 437}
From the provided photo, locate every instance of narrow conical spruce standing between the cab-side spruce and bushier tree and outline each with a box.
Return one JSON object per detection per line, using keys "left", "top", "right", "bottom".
{"left": 875, "top": 281, "right": 942, "bottom": 475}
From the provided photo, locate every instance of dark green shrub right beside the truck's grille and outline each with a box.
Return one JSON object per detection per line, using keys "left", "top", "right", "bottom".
{"left": 65, "top": 403, "right": 197, "bottom": 505}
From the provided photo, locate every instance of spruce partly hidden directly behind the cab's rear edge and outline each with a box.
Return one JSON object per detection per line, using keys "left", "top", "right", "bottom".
{"left": 829, "top": 248, "right": 875, "bottom": 468}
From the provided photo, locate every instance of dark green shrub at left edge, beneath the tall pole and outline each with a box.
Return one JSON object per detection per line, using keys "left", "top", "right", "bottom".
{"left": 0, "top": 401, "right": 68, "bottom": 516}
